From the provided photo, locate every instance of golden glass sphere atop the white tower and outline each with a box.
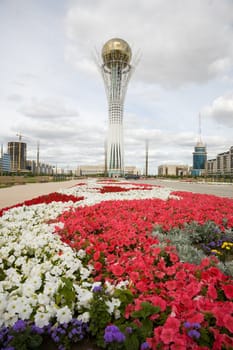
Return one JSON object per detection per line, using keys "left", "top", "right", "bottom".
{"left": 102, "top": 38, "right": 132, "bottom": 67}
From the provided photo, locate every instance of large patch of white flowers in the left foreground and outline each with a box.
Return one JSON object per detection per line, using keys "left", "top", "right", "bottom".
{"left": 0, "top": 197, "right": 133, "bottom": 327}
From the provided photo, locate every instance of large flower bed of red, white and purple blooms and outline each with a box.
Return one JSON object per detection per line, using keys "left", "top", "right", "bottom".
{"left": 0, "top": 181, "right": 233, "bottom": 350}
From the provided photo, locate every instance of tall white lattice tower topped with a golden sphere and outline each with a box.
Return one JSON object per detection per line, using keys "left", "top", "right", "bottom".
{"left": 101, "top": 38, "right": 132, "bottom": 177}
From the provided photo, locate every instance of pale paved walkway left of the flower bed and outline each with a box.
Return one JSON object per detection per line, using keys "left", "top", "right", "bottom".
{"left": 0, "top": 180, "right": 79, "bottom": 209}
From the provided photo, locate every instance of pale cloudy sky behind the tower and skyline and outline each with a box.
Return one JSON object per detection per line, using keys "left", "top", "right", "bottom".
{"left": 0, "top": 0, "right": 233, "bottom": 174}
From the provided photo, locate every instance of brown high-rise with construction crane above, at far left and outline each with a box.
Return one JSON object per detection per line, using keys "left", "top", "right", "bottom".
{"left": 8, "top": 142, "right": 27, "bottom": 172}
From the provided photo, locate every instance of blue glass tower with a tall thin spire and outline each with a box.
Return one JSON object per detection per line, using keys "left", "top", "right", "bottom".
{"left": 192, "top": 114, "right": 207, "bottom": 176}
